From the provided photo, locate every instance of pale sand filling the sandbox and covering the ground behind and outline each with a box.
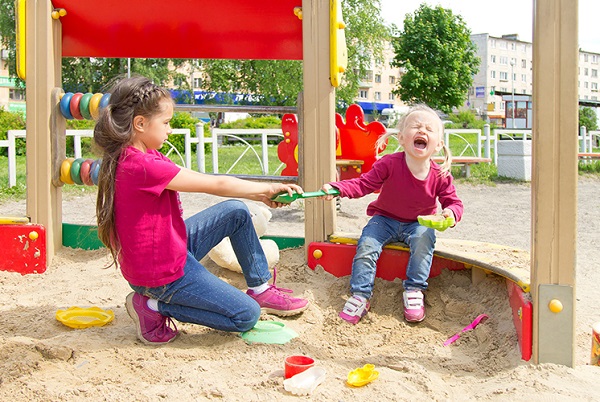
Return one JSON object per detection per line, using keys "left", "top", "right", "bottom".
{"left": 0, "top": 178, "right": 600, "bottom": 401}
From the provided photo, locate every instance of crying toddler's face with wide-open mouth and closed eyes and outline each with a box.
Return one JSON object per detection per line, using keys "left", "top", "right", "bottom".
{"left": 398, "top": 110, "right": 443, "bottom": 159}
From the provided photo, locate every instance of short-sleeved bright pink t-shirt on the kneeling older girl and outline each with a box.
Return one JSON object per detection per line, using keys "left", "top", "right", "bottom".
{"left": 115, "top": 147, "right": 187, "bottom": 287}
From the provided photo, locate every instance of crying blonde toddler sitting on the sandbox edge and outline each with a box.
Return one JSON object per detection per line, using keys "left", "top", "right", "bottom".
{"left": 323, "top": 105, "right": 463, "bottom": 324}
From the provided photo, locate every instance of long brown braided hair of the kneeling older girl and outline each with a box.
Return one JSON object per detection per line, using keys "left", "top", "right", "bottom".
{"left": 94, "top": 76, "right": 172, "bottom": 265}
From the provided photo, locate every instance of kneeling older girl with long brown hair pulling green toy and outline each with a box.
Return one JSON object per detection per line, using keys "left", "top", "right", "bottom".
{"left": 94, "top": 77, "right": 308, "bottom": 344}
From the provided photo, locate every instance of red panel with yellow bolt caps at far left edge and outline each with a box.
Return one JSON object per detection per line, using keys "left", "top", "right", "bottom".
{"left": 0, "top": 224, "right": 47, "bottom": 274}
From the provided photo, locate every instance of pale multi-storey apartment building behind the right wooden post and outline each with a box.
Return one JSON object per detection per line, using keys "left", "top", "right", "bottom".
{"left": 464, "top": 33, "right": 600, "bottom": 128}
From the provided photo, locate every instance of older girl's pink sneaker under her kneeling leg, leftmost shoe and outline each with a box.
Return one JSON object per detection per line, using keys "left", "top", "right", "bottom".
{"left": 125, "top": 292, "right": 178, "bottom": 345}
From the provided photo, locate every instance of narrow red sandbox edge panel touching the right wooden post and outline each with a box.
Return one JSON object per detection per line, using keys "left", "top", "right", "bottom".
{"left": 506, "top": 280, "right": 533, "bottom": 361}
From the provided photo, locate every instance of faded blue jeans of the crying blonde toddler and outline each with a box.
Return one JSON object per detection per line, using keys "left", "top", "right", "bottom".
{"left": 350, "top": 215, "right": 435, "bottom": 299}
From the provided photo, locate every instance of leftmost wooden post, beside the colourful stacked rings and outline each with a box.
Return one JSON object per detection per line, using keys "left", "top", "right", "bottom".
{"left": 25, "top": 0, "right": 62, "bottom": 265}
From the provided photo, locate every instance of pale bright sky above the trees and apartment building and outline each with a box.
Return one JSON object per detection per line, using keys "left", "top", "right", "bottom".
{"left": 381, "top": 0, "right": 600, "bottom": 53}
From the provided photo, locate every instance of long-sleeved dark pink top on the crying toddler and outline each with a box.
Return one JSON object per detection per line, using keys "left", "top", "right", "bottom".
{"left": 330, "top": 152, "right": 464, "bottom": 223}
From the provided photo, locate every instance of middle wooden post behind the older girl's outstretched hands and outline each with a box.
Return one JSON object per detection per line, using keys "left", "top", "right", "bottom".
{"left": 299, "top": 0, "right": 335, "bottom": 244}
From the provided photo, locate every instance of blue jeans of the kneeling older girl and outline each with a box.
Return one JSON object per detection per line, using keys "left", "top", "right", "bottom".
{"left": 130, "top": 200, "right": 271, "bottom": 332}
